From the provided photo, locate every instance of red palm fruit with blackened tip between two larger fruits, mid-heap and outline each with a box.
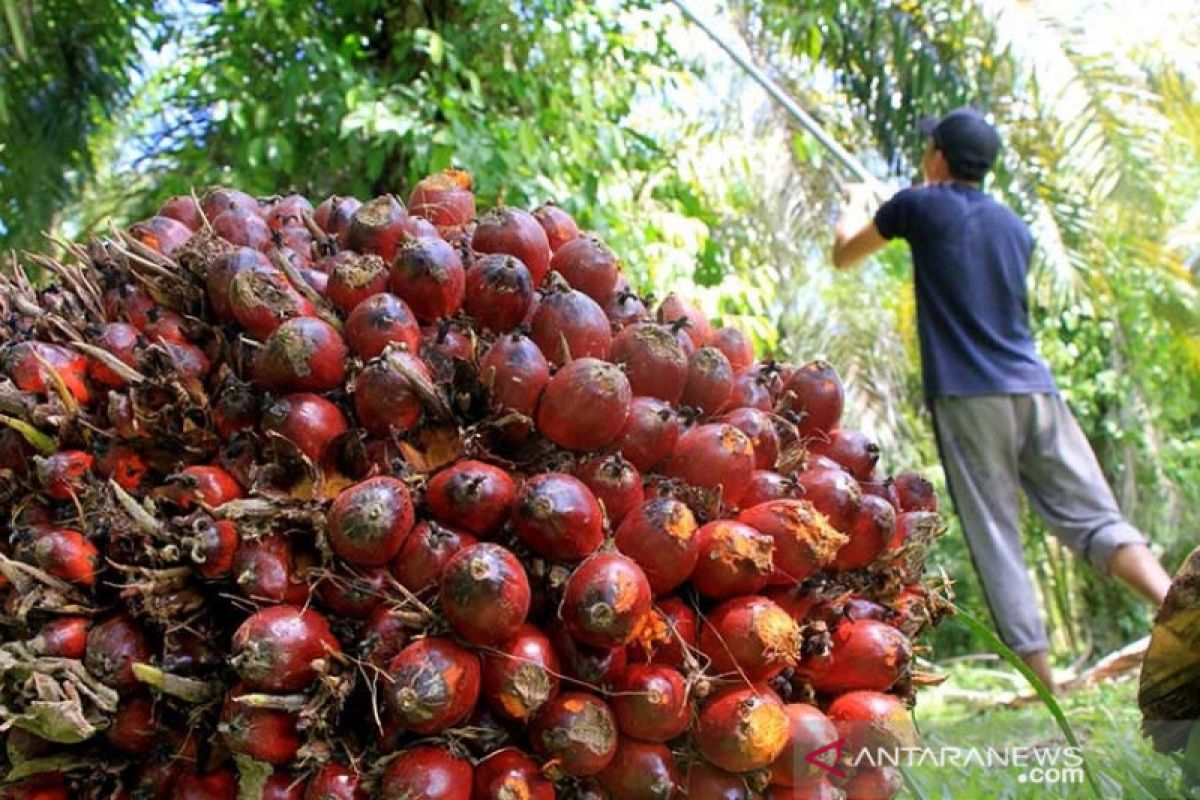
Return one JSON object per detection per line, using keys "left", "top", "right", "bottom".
{"left": 425, "top": 459, "right": 516, "bottom": 539}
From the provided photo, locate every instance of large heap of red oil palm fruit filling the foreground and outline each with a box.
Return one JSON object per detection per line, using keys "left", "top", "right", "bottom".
{"left": 0, "top": 170, "right": 944, "bottom": 800}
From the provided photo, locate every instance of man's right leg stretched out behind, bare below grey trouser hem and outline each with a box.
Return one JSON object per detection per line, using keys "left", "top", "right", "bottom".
{"left": 1021, "top": 395, "right": 1171, "bottom": 606}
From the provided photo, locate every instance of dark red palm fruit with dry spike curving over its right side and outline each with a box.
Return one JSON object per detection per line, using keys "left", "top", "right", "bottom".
{"left": 354, "top": 349, "right": 436, "bottom": 437}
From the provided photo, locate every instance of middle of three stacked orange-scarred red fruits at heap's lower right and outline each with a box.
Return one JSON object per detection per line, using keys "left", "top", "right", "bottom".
{"left": 700, "top": 595, "right": 800, "bottom": 681}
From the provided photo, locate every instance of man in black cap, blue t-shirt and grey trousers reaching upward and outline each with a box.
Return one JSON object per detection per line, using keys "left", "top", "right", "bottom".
{"left": 833, "top": 108, "right": 1170, "bottom": 690}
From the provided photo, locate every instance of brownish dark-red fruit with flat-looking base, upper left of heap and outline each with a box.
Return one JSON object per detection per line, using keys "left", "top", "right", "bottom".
{"left": 251, "top": 317, "right": 347, "bottom": 392}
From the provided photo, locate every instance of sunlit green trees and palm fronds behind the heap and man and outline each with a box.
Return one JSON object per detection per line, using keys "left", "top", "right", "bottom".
{"left": 0, "top": 0, "right": 1200, "bottom": 791}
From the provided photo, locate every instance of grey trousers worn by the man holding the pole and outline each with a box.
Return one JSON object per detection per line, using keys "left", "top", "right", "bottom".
{"left": 930, "top": 395, "right": 1146, "bottom": 655}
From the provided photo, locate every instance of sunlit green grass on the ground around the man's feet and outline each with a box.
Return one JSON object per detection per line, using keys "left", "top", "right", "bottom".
{"left": 904, "top": 663, "right": 1200, "bottom": 800}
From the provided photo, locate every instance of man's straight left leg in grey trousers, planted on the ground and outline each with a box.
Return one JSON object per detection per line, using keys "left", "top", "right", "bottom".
{"left": 932, "top": 395, "right": 1052, "bottom": 686}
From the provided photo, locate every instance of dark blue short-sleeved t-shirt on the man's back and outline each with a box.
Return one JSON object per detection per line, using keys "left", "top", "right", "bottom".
{"left": 875, "top": 184, "right": 1056, "bottom": 397}
